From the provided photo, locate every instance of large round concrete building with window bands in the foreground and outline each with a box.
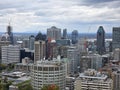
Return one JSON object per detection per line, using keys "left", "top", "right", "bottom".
{"left": 31, "top": 60, "right": 66, "bottom": 90}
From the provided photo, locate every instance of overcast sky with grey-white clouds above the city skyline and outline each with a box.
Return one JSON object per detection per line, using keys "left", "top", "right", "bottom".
{"left": 0, "top": 0, "right": 120, "bottom": 33}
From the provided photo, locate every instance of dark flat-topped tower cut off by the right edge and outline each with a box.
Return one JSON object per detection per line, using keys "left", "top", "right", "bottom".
{"left": 112, "top": 27, "right": 120, "bottom": 50}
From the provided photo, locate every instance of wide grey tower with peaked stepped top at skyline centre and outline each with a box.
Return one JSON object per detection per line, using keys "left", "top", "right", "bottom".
{"left": 47, "top": 26, "right": 61, "bottom": 40}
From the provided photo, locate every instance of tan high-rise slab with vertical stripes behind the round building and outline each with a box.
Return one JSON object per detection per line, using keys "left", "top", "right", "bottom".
{"left": 34, "top": 41, "right": 45, "bottom": 63}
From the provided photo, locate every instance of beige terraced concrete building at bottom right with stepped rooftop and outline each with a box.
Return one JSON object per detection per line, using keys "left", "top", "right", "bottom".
{"left": 74, "top": 69, "right": 113, "bottom": 90}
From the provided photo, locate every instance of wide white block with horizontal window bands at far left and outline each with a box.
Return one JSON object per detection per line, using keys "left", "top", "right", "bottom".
{"left": 2, "top": 45, "right": 20, "bottom": 64}
